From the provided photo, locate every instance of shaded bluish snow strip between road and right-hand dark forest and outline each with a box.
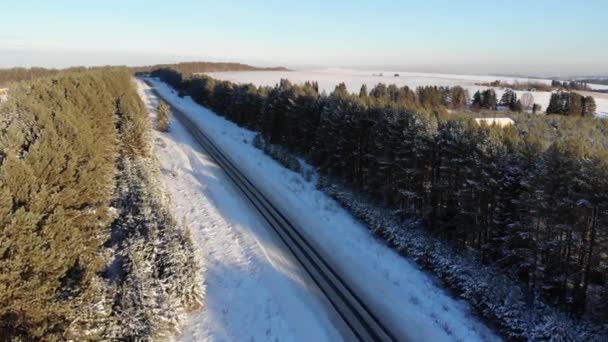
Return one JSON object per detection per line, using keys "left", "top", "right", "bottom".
{"left": 145, "top": 80, "right": 499, "bottom": 341}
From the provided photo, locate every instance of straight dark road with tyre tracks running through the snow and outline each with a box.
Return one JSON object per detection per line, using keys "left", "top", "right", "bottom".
{"left": 144, "top": 79, "right": 397, "bottom": 341}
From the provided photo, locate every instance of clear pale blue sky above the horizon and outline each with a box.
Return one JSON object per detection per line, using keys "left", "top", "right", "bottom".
{"left": 0, "top": 0, "right": 608, "bottom": 75}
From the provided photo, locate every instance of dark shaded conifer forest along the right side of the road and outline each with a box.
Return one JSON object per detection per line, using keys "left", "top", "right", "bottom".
{"left": 152, "top": 69, "right": 608, "bottom": 319}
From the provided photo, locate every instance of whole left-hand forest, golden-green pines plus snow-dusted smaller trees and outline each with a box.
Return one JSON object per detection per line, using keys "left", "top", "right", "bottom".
{"left": 0, "top": 68, "right": 200, "bottom": 341}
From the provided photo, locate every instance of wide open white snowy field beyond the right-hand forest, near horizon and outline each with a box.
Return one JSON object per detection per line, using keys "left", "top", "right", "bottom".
{"left": 209, "top": 69, "right": 608, "bottom": 116}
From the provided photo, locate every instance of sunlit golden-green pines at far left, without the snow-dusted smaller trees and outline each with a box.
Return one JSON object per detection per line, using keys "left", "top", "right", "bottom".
{"left": 0, "top": 68, "right": 133, "bottom": 339}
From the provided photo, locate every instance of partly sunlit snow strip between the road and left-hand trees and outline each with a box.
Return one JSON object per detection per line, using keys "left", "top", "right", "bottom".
{"left": 137, "top": 81, "right": 340, "bottom": 341}
